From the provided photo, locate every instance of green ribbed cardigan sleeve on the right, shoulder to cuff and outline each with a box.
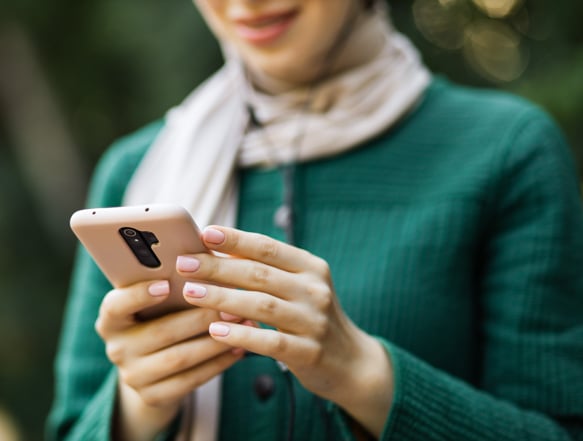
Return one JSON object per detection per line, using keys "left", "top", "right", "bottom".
{"left": 381, "top": 109, "right": 583, "bottom": 441}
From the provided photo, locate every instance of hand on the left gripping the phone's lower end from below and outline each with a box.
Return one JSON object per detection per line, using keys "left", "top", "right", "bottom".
{"left": 95, "top": 281, "right": 243, "bottom": 441}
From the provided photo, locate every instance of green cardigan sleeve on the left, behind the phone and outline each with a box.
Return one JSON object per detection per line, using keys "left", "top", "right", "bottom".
{"left": 46, "top": 123, "right": 160, "bottom": 441}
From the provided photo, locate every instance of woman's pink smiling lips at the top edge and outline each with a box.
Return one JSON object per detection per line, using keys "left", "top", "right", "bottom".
{"left": 235, "top": 11, "right": 298, "bottom": 45}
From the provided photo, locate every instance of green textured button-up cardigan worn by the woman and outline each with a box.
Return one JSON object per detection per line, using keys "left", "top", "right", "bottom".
{"left": 48, "top": 79, "right": 583, "bottom": 441}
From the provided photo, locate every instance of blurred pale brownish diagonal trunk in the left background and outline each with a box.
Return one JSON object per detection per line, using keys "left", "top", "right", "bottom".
{"left": 0, "top": 24, "right": 86, "bottom": 250}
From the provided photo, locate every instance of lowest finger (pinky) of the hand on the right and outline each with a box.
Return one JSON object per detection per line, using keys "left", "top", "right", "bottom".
{"left": 209, "top": 322, "right": 322, "bottom": 367}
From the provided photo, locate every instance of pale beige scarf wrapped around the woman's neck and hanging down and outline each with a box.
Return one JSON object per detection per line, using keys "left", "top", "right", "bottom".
{"left": 124, "top": 6, "right": 431, "bottom": 441}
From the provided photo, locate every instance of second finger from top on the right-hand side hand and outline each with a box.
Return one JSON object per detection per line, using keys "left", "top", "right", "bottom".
{"left": 176, "top": 254, "right": 307, "bottom": 300}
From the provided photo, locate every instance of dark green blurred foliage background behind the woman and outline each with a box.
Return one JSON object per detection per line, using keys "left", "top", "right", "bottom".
{"left": 0, "top": 0, "right": 583, "bottom": 441}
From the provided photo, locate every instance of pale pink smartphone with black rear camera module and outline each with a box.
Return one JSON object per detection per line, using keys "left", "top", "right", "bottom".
{"left": 70, "top": 204, "right": 208, "bottom": 320}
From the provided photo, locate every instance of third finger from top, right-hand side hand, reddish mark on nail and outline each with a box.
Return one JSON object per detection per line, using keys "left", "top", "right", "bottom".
{"left": 183, "top": 282, "right": 310, "bottom": 333}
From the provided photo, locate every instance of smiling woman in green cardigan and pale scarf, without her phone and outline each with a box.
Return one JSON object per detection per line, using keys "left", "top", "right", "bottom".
{"left": 49, "top": 0, "right": 583, "bottom": 441}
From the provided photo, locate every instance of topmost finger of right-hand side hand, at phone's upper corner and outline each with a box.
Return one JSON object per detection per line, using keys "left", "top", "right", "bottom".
{"left": 202, "top": 226, "right": 327, "bottom": 273}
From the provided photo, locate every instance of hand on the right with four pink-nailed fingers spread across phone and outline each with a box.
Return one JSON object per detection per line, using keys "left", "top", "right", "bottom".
{"left": 177, "top": 227, "right": 393, "bottom": 436}
